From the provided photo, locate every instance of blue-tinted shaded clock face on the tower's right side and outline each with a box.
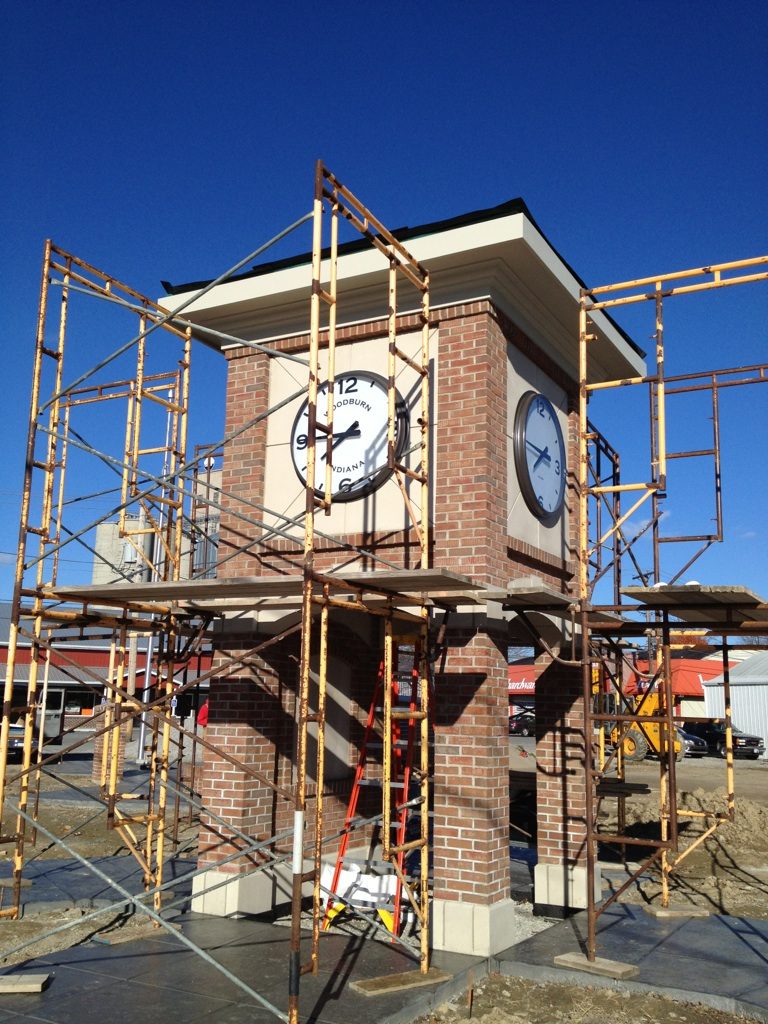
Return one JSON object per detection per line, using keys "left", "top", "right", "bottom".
{"left": 513, "top": 391, "right": 566, "bottom": 524}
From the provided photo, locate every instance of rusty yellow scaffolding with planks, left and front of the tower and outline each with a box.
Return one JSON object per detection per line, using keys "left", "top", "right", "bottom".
{"left": 0, "top": 163, "right": 473, "bottom": 1022}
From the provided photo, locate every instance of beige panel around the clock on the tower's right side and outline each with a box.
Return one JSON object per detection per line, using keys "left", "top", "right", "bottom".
{"left": 507, "top": 344, "right": 573, "bottom": 559}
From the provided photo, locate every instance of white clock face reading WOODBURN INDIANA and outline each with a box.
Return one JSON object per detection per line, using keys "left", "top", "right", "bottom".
{"left": 291, "top": 370, "right": 408, "bottom": 502}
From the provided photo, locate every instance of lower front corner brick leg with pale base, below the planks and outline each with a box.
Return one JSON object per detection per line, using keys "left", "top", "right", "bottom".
{"left": 433, "top": 614, "right": 512, "bottom": 955}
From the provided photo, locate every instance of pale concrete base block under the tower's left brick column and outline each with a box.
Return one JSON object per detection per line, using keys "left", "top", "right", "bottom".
{"left": 191, "top": 864, "right": 312, "bottom": 918}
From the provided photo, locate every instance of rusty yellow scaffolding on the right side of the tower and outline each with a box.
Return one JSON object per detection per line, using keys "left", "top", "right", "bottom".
{"left": 578, "top": 257, "right": 768, "bottom": 961}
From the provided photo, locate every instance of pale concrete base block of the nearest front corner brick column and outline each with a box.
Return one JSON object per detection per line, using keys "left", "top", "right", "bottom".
{"left": 432, "top": 899, "right": 519, "bottom": 956}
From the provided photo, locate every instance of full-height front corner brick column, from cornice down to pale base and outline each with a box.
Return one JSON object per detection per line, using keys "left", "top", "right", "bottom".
{"left": 433, "top": 303, "right": 512, "bottom": 955}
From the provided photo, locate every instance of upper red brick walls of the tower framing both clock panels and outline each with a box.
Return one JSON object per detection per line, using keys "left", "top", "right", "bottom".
{"left": 218, "top": 300, "right": 577, "bottom": 586}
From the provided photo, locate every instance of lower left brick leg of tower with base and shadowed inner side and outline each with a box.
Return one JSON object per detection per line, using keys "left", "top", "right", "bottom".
{"left": 194, "top": 612, "right": 381, "bottom": 916}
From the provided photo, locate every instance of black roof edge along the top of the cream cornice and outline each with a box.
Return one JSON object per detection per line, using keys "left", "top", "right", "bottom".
{"left": 160, "top": 197, "right": 646, "bottom": 358}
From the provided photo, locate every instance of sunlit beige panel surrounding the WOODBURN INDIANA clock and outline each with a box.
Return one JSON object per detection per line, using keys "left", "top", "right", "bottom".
{"left": 264, "top": 330, "right": 438, "bottom": 540}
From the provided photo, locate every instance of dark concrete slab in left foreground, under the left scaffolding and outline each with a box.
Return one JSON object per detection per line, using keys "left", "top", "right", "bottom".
{"left": 0, "top": 914, "right": 487, "bottom": 1024}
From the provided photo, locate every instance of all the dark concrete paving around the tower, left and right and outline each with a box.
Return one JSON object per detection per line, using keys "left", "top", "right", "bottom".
{"left": 0, "top": 857, "right": 768, "bottom": 1024}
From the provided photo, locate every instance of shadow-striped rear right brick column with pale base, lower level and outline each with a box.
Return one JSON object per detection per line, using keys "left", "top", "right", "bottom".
{"left": 534, "top": 663, "right": 599, "bottom": 916}
